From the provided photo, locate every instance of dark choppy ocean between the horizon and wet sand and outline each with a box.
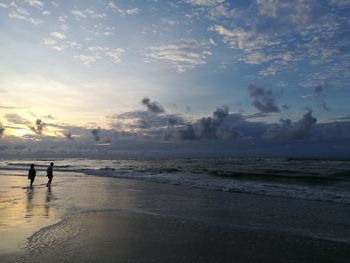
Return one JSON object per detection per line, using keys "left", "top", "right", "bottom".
{"left": 0, "top": 158, "right": 350, "bottom": 204}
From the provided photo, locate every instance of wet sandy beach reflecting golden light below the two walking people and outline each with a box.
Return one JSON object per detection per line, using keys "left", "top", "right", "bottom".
{"left": 0, "top": 173, "right": 350, "bottom": 262}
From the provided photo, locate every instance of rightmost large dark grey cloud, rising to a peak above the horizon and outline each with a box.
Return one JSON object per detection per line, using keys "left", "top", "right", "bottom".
{"left": 265, "top": 110, "right": 317, "bottom": 139}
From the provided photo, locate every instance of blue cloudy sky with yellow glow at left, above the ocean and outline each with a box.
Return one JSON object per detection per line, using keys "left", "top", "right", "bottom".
{"left": 0, "top": 0, "right": 350, "bottom": 157}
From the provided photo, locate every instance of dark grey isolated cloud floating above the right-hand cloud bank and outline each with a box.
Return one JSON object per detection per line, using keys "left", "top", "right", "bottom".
{"left": 248, "top": 84, "right": 280, "bottom": 113}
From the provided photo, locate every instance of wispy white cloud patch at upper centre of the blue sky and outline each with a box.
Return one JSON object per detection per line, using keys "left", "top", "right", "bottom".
{"left": 145, "top": 39, "right": 215, "bottom": 73}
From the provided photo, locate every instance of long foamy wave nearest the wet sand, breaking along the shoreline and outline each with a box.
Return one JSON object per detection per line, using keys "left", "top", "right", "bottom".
{"left": 82, "top": 168, "right": 350, "bottom": 204}
